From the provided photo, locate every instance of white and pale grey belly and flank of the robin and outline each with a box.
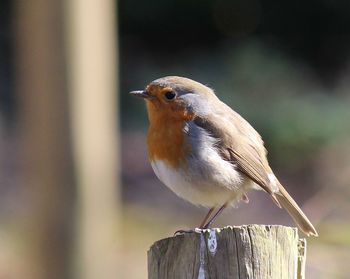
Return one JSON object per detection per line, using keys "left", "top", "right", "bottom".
{"left": 151, "top": 122, "right": 254, "bottom": 207}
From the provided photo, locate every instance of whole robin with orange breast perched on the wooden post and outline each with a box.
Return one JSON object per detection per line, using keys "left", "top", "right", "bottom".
{"left": 130, "top": 76, "right": 318, "bottom": 236}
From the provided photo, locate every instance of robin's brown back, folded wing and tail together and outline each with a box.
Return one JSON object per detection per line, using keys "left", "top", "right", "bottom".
{"left": 194, "top": 99, "right": 317, "bottom": 236}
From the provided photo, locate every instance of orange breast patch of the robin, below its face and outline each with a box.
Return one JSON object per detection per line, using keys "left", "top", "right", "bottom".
{"left": 147, "top": 102, "right": 192, "bottom": 168}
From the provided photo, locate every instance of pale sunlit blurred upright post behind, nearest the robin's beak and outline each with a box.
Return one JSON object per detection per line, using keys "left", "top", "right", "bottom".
{"left": 65, "top": 0, "right": 120, "bottom": 279}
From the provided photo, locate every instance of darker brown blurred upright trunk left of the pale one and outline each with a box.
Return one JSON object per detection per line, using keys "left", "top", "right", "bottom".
{"left": 14, "top": 0, "right": 74, "bottom": 279}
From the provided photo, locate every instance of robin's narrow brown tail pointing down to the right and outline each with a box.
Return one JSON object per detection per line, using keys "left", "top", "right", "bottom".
{"left": 274, "top": 184, "right": 318, "bottom": 236}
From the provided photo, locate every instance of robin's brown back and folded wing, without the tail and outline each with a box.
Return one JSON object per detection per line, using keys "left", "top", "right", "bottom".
{"left": 194, "top": 102, "right": 274, "bottom": 195}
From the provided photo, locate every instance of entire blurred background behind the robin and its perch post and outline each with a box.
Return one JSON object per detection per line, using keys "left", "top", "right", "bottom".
{"left": 0, "top": 0, "right": 350, "bottom": 279}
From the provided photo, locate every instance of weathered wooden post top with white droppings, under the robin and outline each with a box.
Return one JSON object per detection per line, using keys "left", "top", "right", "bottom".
{"left": 148, "top": 225, "right": 306, "bottom": 279}
